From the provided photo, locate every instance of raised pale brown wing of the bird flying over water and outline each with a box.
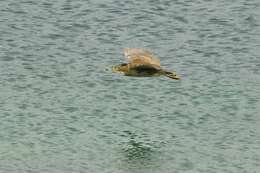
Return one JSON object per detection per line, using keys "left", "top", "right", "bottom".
{"left": 124, "top": 48, "right": 161, "bottom": 68}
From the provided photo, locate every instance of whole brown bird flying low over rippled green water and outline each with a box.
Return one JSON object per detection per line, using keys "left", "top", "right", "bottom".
{"left": 112, "top": 48, "right": 181, "bottom": 80}
